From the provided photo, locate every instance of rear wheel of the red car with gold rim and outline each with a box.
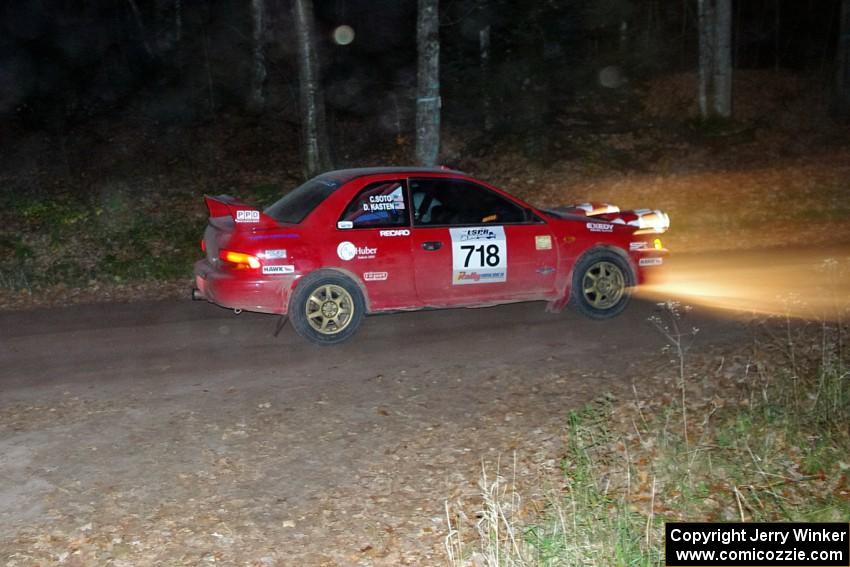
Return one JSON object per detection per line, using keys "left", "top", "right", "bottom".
{"left": 289, "top": 271, "right": 366, "bottom": 345}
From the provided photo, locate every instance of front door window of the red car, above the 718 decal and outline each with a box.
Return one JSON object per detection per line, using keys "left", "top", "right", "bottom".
{"left": 410, "top": 179, "right": 526, "bottom": 226}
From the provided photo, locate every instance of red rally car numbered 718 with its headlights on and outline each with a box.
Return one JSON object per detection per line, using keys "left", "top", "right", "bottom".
{"left": 192, "top": 167, "right": 670, "bottom": 344}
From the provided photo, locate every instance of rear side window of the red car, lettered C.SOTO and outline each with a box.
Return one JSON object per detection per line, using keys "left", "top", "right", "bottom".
{"left": 337, "top": 181, "right": 410, "bottom": 228}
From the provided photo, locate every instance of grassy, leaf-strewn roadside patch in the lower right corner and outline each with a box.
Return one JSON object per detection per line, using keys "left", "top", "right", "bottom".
{"left": 447, "top": 304, "right": 850, "bottom": 567}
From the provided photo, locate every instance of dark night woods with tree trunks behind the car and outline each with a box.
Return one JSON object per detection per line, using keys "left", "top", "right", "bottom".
{"left": 0, "top": 0, "right": 850, "bottom": 174}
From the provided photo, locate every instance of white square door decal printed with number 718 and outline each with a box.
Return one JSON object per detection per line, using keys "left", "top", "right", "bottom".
{"left": 449, "top": 226, "right": 508, "bottom": 285}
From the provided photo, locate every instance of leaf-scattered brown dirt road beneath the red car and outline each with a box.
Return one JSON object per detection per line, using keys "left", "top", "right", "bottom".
{"left": 0, "top": 301, "right": 739, "bottom": 565}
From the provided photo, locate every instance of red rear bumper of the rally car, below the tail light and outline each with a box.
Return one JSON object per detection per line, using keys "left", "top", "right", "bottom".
{"left": 193, "top": 260, "right": 295, "bottom": 314}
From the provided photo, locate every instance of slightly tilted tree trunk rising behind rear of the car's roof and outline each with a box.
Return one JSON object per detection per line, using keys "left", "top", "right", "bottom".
{"left": 292, "top": 0, "right": 331, "bottom": 178}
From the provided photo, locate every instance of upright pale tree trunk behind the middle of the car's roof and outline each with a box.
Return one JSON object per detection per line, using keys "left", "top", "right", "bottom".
{"left": 416, "top": 0, "right": 440, "bottom": 167}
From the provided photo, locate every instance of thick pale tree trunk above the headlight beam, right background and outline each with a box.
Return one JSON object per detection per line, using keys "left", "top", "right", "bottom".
{"left": 697, "top": 0, "right": 732, "bottom": 120}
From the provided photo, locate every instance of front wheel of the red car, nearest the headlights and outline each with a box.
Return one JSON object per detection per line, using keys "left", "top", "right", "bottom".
{"left": 570, "top": 248, "right": 635, "bottom": 319}
